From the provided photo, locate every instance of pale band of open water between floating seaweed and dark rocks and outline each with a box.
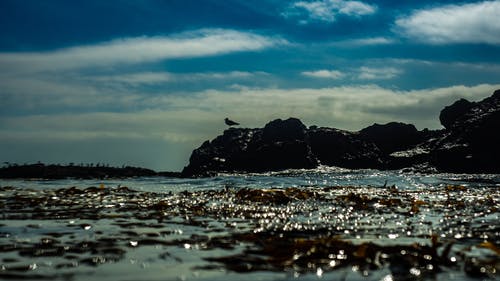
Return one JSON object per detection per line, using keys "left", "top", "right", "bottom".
{"left": 0, "top": 167, "right": 500, "bottom": 192}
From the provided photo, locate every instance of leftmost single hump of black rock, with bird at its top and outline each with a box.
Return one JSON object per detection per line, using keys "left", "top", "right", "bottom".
{"left": 183, "top": 118, "right": 318, "bottom": 176}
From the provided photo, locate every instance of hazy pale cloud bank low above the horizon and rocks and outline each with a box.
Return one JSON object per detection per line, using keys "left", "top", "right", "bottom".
{"left": 0, "top": 81, "right": 500, "bottom": 169}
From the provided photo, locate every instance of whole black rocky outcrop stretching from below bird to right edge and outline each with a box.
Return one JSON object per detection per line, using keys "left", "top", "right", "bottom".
{"left": 182, "top": 90, "right": 500, "bottom": 177}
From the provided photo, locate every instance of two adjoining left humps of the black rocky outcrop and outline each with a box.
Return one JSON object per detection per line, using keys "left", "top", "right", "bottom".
{"left": 182, "top": 118, "right": 382, "bottom": 176}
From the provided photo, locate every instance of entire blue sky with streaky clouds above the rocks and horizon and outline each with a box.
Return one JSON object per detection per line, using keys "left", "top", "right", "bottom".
{"left": 0, "top": 0, "right": 500, "bottom": 171}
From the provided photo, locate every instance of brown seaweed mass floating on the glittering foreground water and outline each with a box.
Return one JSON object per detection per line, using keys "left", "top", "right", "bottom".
{"left": 0, "top": 186, "right": 500, "bottom": 280}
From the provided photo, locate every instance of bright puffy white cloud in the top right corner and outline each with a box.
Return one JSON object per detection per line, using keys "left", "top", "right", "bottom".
{"left": 395, "top": 1, "right": 500, "bottom": 45}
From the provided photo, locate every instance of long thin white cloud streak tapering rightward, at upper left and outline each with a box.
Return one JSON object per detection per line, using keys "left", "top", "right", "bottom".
{"left": 0, "top": 29, "right": 286, "bottom": 73}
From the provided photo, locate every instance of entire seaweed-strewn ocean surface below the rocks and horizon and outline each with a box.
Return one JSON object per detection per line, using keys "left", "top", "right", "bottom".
{"left": 0, "top": 167, "right": 500, "bottom": 281}
